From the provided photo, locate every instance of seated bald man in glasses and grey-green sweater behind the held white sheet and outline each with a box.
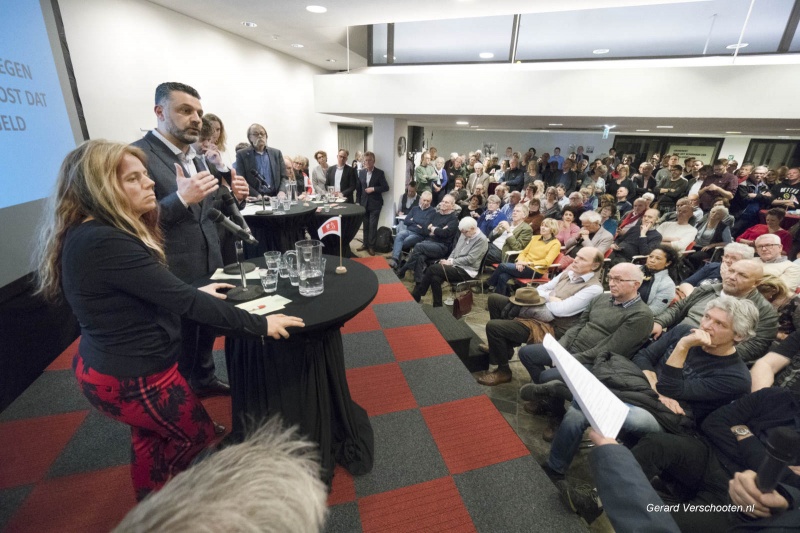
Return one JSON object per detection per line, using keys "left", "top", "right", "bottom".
{"left": 519, "top": 263, "right": 653, "bottom": 440}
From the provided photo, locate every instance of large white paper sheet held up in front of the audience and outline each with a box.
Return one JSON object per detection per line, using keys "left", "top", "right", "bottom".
{"left": 543, "top": 333, "right": 630, "bottom": 439}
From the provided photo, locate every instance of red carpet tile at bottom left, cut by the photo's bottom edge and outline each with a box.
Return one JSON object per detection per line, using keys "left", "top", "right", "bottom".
{"left": 6, "top": 466, "right": 136, "bottom": 533}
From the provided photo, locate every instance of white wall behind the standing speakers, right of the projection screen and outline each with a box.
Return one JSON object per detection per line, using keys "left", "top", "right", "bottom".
{"left": 59, "top": 0, "right": 337, "bottom": 160}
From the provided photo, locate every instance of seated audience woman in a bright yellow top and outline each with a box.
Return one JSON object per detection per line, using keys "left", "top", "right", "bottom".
{"left": 486, "top": 218, "right": 561, "bottom": 296}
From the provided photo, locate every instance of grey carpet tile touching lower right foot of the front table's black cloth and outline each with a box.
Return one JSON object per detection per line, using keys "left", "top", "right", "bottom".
{"left": 355, "top": 409, "right": 448, "bottom": 498}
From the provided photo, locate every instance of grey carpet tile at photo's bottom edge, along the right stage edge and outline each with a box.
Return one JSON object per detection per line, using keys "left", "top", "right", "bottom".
{"left": 453, "top": 456, "right": 587, "bottom": 533}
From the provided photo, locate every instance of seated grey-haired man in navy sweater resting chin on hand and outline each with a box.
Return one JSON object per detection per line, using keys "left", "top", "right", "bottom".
{"left": 545, "top": 297, "right": 758, "bottom": 488}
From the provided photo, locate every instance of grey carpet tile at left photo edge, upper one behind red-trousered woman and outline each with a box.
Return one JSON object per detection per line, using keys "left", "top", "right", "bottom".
{"left": 0, "top": 370, "right": 91, "bottom": 422}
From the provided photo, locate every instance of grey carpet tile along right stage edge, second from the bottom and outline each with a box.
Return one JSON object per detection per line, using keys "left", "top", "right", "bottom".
{"left": 400, "top": 354, "right": 483, "bottom": 407}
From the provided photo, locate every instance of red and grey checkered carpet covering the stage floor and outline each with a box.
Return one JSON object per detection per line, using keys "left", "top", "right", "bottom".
{"left": 0, "top": 257, "right": 585, "bottom": 533}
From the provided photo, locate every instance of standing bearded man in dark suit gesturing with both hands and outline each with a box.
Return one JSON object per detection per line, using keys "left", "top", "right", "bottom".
{"left": 133, "top": 82, "right": 247, "bottom": 397}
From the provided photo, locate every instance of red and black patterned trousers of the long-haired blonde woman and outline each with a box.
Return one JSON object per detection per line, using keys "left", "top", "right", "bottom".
{"left": 72, "top": 354, "right": 214, "bottom": 500}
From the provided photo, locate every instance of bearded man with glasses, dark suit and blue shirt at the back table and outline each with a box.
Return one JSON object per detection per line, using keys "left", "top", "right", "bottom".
{"left": 235, "top": 124, "right": 289, "bottom": 196}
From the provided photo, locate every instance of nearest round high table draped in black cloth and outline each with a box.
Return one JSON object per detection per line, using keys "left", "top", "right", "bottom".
{"left": 219, "top": 256, "right": 378, "bottom": 483}
